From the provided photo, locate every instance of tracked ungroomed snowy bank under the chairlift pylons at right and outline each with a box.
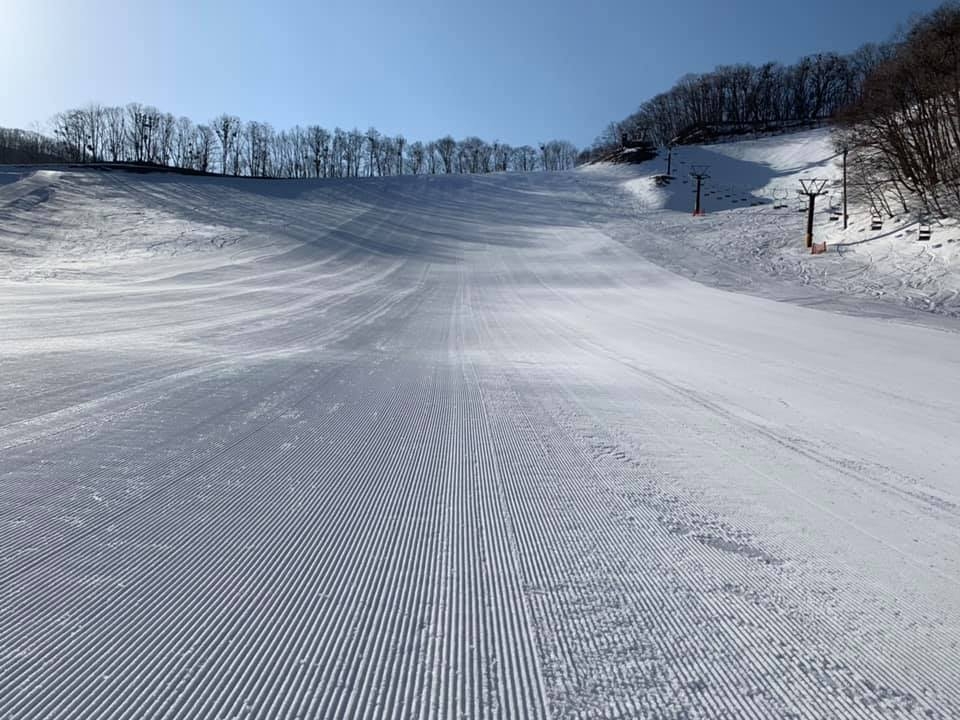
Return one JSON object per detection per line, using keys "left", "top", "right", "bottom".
{"left": 583, "top": 129, "right": 960, "bottom": 316}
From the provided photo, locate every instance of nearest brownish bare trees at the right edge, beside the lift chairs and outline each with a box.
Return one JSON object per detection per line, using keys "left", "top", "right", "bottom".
{"left": 835, "top": 3, "right": 960, "bottom": 217}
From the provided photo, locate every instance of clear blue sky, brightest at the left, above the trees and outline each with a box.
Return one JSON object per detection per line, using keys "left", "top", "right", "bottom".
{"left": 0, "top": 0, "right": 940, "bottom": 146}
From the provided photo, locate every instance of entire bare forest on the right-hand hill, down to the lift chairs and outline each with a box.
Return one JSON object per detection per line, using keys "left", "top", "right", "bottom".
{"left": 580, "top": 1, "right": 960, "bottom": 217}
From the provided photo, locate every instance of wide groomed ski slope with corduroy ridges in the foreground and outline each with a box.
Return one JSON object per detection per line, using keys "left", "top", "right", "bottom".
{"left": 0, "top": 160, "right": 960, "bottom": 720}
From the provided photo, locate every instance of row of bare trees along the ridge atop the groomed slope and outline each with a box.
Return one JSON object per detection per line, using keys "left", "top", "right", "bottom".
{"left": 11, "top": 103, "right": 578, "bottom": 178}
